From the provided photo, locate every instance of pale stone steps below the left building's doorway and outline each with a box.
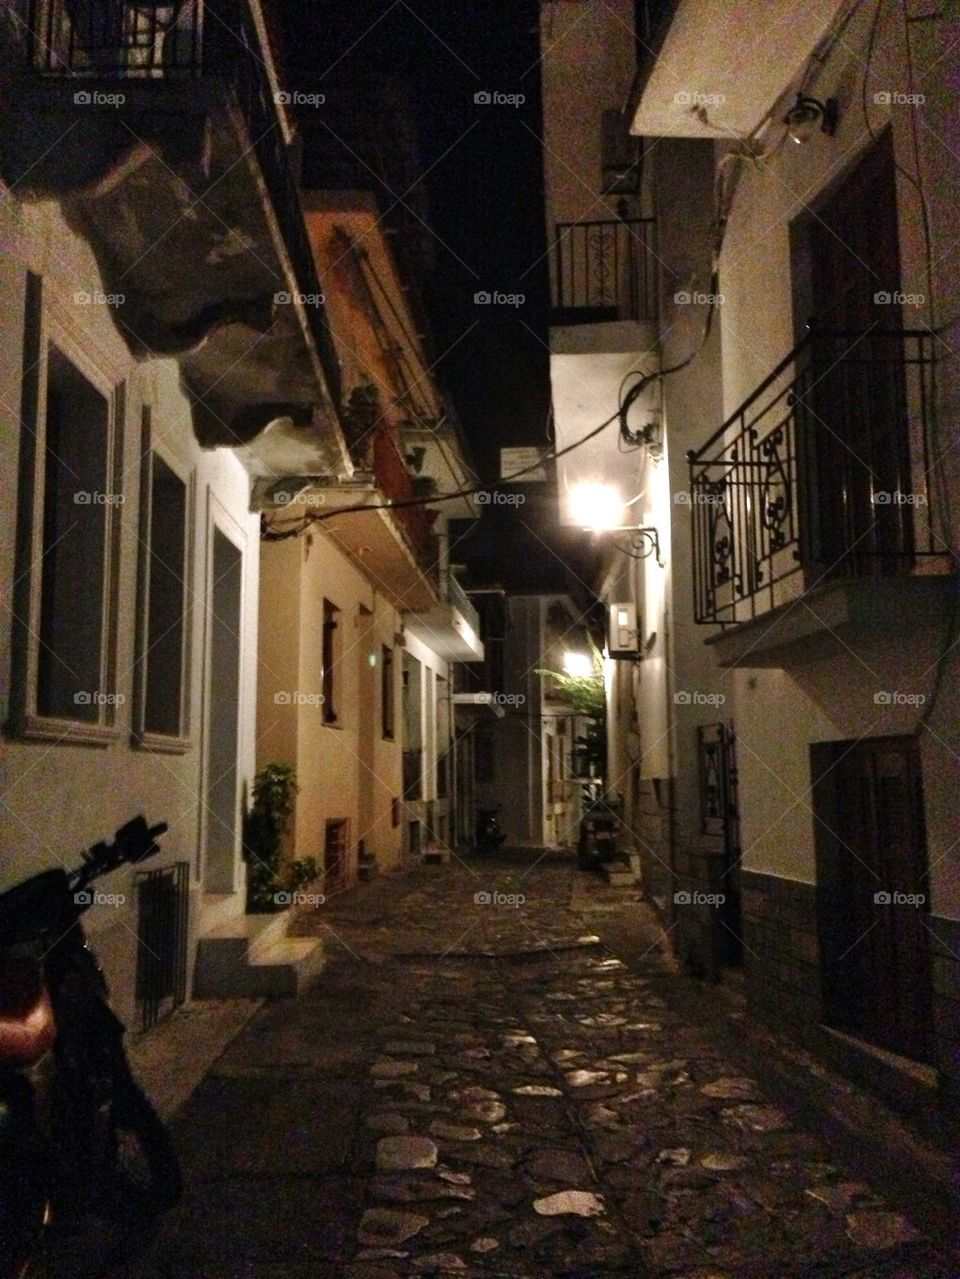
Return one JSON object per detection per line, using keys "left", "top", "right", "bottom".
{"left": 193, "top": 911, "right": 325, "bottom": 999}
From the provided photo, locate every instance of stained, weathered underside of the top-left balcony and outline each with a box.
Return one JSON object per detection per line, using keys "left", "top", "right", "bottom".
{"left": 0, "top": 73, "right": 349, "bottom": 475}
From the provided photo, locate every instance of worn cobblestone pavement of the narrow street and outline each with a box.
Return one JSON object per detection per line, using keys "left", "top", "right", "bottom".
{"left": 131, "top": 861, "right": 960, "bottom": 1279}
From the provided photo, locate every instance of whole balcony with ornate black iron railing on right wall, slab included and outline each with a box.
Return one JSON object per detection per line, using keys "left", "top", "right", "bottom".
{"left": 688, "top": 329, "right": 955, "bottom": 666}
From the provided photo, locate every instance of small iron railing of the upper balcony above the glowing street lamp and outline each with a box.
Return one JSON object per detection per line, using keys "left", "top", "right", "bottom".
{"left": 554, "top": 217, "right": 657, "bottom": 324}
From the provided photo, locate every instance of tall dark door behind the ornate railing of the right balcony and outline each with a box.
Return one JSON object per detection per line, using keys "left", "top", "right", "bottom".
{"left": 807, "top": 132, "right": 913, "bottom": 576}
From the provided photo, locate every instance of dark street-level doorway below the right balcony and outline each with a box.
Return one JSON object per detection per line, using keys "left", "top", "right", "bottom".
{"left": 810, "top": 737, "right": 933, "bottom": 1063}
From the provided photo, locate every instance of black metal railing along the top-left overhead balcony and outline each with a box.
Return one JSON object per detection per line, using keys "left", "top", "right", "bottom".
{"left": 20, "top": 0, "right": 340, "bottom": 403}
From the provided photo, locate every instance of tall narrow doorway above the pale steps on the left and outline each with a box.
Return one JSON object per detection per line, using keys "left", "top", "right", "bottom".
{"left": 203, "top": 524, "right": 243, "bottom": 893}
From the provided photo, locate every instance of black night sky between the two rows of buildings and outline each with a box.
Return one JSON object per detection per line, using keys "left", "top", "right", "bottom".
{"left": 276, "top": 0, "right": 600, "bottom": 598}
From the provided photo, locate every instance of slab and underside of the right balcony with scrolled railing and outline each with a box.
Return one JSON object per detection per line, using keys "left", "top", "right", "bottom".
{"left": 706, "top": 573, "right": 960, "bottom": 669}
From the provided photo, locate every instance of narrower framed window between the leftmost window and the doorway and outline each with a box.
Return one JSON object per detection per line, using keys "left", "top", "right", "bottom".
{"left": 135, "top": 407, "right": 190, "bottom": 749}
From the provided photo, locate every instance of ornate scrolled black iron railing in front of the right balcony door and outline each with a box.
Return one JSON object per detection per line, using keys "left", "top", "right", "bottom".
{"left": 688, "top": 329, "right": 948, "bottom": 624}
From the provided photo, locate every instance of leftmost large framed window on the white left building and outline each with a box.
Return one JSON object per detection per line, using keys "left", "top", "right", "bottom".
{"left": 13, "top": 276, "right": 124, "bottom": 742}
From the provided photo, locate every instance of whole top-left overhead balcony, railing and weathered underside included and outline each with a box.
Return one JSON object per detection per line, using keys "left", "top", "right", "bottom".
{"left": 0, "top": 0, "right": 349, "bottom": 475}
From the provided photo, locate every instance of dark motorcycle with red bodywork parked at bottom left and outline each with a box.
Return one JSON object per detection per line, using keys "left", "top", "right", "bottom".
{"left": 0, "top": 816, "right": 183, "bottom": 1279}
